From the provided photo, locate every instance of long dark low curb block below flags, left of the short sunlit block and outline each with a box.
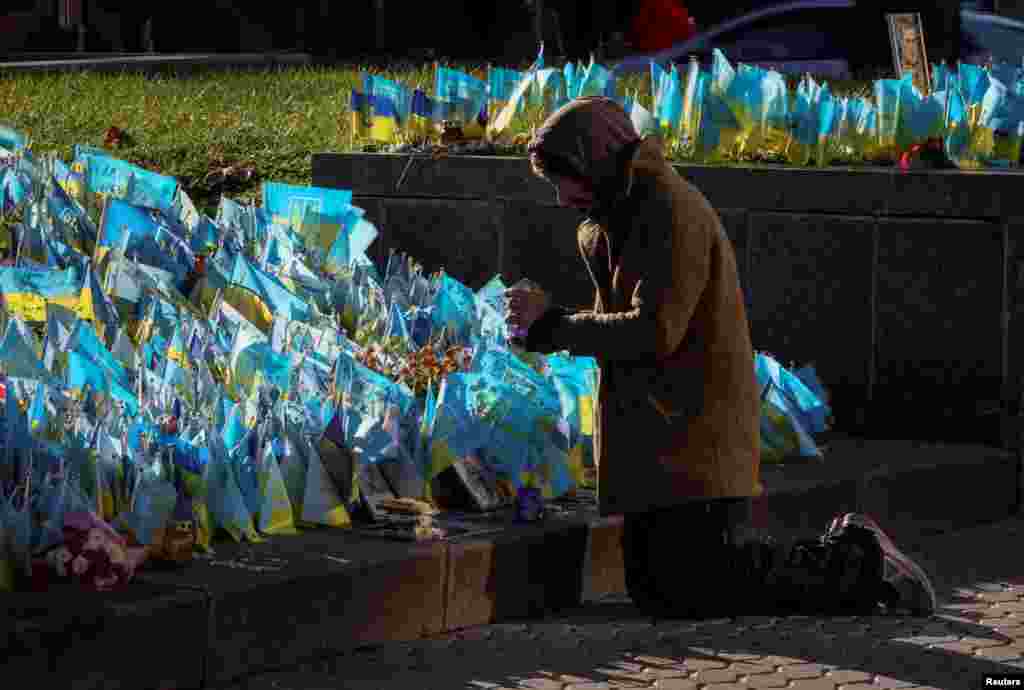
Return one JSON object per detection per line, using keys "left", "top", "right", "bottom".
{"left": 135, "top": 529, "right": 446, "bottom": 683}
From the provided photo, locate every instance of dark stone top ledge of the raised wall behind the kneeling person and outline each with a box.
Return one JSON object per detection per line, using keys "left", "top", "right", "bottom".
{"left": 312, "top": 153, "right": 1024, "bottom": 220}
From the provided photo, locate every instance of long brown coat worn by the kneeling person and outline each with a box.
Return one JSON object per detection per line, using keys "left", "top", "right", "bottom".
{"left": 526, "top": 138, "right": 763, "bottom": 515}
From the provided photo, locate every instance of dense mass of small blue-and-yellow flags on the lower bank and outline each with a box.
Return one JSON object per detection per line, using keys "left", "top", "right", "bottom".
{"left": 0, "top": 110, "right": 824, "bottom": 590}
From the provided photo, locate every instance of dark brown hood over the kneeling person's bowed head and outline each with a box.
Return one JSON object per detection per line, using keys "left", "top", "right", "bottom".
{"left": 527, "top": 96, "right": 640, "bottom": 215}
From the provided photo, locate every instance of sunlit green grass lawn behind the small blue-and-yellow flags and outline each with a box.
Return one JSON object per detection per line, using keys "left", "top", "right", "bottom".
{"left": 0, "top": 63, "right": 880, "bottom": 211}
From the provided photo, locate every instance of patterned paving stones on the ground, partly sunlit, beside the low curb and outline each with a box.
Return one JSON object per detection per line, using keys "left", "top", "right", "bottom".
{"left": 221, "top": 519, "right": 1024, "bottom": 690}
